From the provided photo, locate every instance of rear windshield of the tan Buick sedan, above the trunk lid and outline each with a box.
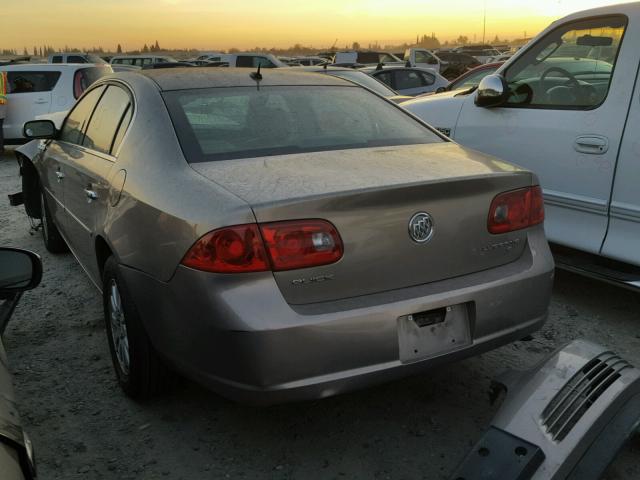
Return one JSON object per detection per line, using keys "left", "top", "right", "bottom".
{"left": 164, "top": 86, "right": 443, "bottom": 163}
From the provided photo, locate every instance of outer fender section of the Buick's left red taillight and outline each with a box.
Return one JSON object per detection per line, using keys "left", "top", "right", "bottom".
{"left": 182, "top": 224, "right": 269, "bottom": 273}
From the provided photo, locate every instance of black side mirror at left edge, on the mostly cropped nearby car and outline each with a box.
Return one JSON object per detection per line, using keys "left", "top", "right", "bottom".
{"left": 0, "top": 247, "right": 42, "bottom": 297}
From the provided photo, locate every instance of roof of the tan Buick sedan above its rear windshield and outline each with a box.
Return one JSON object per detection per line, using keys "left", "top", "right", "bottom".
{"left": 136, "top": 67, "right": 353, "bottom": 91}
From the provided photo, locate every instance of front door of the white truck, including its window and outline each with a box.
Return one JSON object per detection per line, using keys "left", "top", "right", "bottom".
{"left": 453, "top": 15, "right": 638, "bottom": 254}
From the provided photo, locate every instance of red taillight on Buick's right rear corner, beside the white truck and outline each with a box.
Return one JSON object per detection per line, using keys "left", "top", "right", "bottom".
{"left": 488, "top": 185, "right": 544, "bottom": 233}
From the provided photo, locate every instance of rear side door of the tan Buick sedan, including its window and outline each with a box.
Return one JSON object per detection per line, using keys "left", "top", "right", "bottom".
{"left": 65, "top": 85, "right": 132, "bottom": 282}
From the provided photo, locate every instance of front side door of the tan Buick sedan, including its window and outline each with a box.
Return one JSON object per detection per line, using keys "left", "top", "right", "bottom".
{"left": 40, "top": 87, "right": 104, "bottom": 238}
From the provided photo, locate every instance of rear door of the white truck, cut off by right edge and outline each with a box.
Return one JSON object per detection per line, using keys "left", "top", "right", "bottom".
{"left": 601, "top": 59, "right": 640, "bottom": 266}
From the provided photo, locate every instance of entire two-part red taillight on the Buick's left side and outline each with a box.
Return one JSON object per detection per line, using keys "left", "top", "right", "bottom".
{"left": 182, "top": 220, "right": 343, "bottom": 273}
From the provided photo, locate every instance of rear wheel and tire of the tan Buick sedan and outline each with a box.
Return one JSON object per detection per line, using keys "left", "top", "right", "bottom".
{"left": 102, "top": 256, "right": 171, "bottom": 400}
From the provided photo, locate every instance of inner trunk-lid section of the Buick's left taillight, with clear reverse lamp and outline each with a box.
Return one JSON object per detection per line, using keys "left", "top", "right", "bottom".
{"left": 260, "top": 220, "right": 343, "bottom": 271}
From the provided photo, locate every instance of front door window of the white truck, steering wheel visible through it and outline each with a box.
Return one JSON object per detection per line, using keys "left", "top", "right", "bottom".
{"left": 505, "top": 15, "right": 627, "bottom": 109}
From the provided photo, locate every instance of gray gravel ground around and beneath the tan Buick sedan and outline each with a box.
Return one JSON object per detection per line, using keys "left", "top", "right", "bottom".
{"left": 0, "top": 149, "right": 640, "bottom": 479}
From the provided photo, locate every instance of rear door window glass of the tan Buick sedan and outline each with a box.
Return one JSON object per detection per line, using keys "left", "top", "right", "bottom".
{"left": 82, "top": 85, "right": 131, "bottom": 154}
